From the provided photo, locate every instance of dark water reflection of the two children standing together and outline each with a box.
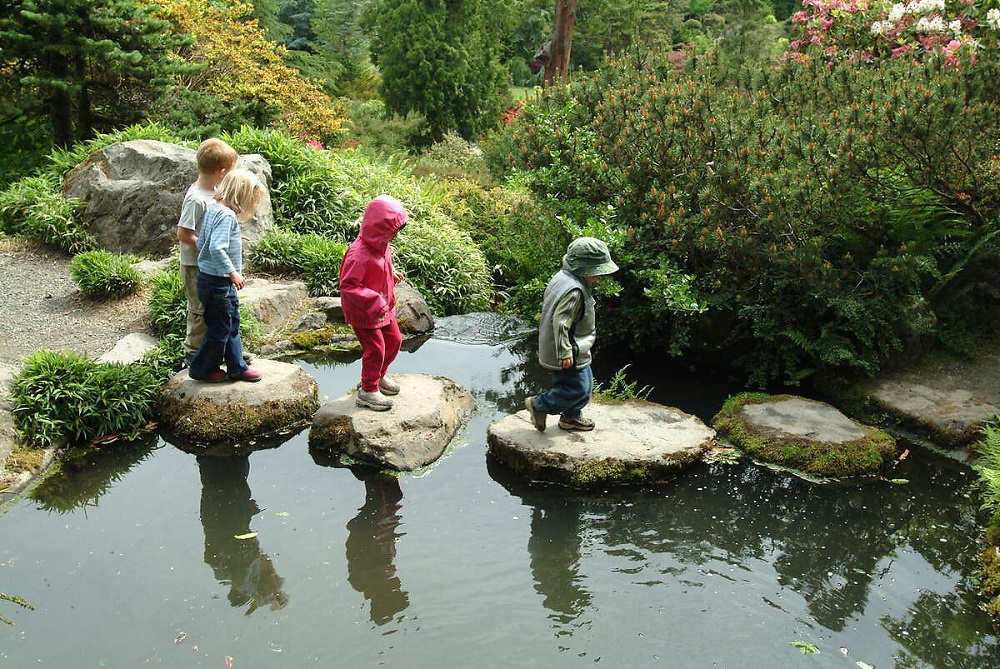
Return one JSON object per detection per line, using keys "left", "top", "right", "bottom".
{"left": 198, "top": 455, "right": 288, "bottom": 615}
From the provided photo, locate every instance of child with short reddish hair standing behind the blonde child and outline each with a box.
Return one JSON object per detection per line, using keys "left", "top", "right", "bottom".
{"left": 177, "top": 138, "right": 238, "bottom": 364}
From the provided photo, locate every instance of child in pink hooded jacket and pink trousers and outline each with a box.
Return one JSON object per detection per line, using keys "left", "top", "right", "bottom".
{"left": 340, "top": 195, "right": 408, "bottom": 411}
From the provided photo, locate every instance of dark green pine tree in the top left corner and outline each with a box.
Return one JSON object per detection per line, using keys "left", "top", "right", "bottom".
{"left": 0, "top": 0, "right": 193, "bottom": 146}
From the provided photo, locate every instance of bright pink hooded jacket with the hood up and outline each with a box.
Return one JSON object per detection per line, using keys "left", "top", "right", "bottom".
{"left": 340, "top": 195, "right": 408, "bottom": 328}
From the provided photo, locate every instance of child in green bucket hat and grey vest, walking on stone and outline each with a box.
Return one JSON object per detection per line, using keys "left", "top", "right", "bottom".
{"left": 524, "top": 237, "right": 618, "bottom": 431}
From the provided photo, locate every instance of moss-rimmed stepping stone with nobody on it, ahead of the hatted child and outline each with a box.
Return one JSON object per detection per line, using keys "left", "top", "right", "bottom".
{"left": 712, "top": 393, "right": 896, "bottom": 478}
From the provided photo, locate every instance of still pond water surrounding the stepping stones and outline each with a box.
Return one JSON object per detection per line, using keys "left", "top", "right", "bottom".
{"left": 0, "top": 320, "right": 1000, "bottom": 669}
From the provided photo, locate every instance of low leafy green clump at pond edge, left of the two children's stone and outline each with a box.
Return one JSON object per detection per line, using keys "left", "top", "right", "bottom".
{"left": 11, "top": 349, "right": 162, "bottom": 447}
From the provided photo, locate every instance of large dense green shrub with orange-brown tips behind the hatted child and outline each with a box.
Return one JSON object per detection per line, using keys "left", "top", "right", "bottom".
{"left": 486, "top": 51, "right": 1000, "bottom": 383}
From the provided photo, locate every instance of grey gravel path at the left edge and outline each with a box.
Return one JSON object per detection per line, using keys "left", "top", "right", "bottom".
{"left": 0, "top": 239, "right": 149, "bottom": 367}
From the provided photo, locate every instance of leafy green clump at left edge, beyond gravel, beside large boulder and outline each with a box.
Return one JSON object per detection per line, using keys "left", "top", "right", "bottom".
{"left": 0, "top": 174, "right": 96, "bottom": 253}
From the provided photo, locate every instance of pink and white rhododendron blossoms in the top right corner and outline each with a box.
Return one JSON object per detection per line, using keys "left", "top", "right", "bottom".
{"left": 787, "top": 0, "right": 1000, "bottom": 67}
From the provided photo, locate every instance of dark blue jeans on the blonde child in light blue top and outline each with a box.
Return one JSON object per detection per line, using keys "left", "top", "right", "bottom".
{"left": 188, "top": 272, "right": 248, "bottom": 378}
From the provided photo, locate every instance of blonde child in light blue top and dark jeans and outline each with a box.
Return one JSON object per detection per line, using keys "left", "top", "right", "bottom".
{"left": 188, "top": 169, "right": 264, "bottom": 383}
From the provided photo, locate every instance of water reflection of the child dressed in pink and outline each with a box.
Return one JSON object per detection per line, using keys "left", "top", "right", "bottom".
{"left": 345, "top": 466, "right": 410, "bottom": 625}
